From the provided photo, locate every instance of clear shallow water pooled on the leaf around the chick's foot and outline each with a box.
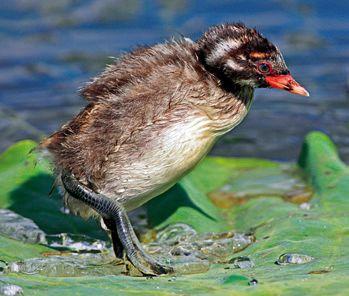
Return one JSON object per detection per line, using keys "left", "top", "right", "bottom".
{"left": 1, "top": 224, "right": 255, "bottom": 277}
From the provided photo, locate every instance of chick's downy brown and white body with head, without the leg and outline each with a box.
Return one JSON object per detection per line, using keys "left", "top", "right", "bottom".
{"left": 41, "top": 24, "right": 305, "bottom": 216}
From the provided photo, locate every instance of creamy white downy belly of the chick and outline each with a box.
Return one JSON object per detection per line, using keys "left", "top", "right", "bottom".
{"left": 103, "top": 117, "right": 215, "bottom": 210}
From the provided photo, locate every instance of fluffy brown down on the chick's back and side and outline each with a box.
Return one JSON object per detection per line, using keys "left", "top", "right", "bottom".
{"left": 41, "top": 43, "right": 204, "bottom": 182}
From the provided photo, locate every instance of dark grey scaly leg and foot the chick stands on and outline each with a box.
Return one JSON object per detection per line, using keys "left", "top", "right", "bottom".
{"left": 61, "top": 171, "right": 173, "bottom": 275}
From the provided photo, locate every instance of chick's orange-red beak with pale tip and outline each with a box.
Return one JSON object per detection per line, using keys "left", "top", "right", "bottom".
{"left": 265, "top": 74, "right": 309, "bottom": 97}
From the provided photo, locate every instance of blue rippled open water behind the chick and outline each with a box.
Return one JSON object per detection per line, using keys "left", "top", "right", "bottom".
{"left": 0, "top": 0, "right": 349, "bottom": 161}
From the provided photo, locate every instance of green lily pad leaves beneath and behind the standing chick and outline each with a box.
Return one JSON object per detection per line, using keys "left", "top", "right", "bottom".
{"left": 0, "top": 132, "right": 349, "bottom": 295}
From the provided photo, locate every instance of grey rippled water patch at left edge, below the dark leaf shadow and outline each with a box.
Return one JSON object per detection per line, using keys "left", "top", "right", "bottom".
{"left": 0, "top": 209, "right": 47, "bottom": 244}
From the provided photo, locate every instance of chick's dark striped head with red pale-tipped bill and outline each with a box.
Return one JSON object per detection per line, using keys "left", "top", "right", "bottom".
{"left": 198, "top": 23, "right": 309, "bottom": 96}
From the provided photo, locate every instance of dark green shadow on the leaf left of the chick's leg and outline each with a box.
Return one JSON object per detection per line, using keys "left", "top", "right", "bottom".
{"left": 9, "top": 173, "right": 107, "bottom": 239}
